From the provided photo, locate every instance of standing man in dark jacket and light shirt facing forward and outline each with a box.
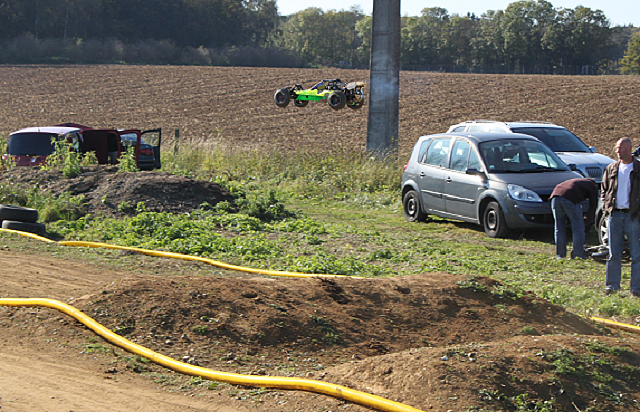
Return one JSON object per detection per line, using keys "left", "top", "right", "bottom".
{"left": 601, "top": 137, "right": 640, "bottom": 297}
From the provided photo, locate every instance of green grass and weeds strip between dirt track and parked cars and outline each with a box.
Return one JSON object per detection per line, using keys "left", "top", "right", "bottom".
{"left": 7, "top": 141, "right": 640, "bottom": 326}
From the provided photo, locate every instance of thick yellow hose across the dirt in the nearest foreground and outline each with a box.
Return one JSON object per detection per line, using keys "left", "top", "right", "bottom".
{"left": 0, "top": 298, "right": 421, "bottom": 412}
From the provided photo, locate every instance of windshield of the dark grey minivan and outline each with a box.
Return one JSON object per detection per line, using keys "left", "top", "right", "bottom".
{"left": 478, "top": 139, "right": 569, "bottom": 173}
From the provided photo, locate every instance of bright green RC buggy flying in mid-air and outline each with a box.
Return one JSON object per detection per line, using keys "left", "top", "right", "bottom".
{"left": 274, "top": 79, "right": 365, "bottom": 110}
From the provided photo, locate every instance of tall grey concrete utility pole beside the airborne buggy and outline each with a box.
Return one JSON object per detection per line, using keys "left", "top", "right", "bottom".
{"left": 367, "top": 0, "right": 400, "bottom": 156}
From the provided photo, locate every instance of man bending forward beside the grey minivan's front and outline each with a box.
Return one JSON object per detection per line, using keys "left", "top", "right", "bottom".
{"left": 551, "top": 179, "right": 598, "bottom": 259}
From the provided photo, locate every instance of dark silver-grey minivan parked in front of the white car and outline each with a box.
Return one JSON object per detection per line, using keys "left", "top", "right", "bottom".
{"left": 402, "top": 132, "right": 582, "bottom": 237}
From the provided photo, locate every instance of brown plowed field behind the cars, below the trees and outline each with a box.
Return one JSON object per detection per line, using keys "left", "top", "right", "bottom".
{"left": 0, "top": 66, "right": 640, "bottom": 158}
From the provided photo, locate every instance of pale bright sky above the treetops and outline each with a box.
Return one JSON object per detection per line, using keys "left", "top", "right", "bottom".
{"left": 276, "top": 0, "right": 640, "bottom": 27}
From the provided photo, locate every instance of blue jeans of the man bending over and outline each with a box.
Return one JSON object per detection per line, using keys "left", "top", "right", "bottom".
{"left": 551, "top": 197, "right": 584, "bottom": 259}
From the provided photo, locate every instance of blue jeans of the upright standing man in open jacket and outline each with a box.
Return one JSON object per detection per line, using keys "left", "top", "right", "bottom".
{"left": 605, "top": 210, "right": 640, "bottom": 292}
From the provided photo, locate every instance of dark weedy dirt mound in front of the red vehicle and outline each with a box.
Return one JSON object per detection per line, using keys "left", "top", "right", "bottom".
{"left": 0, "top": 166, "right": 234, "bottom": 216}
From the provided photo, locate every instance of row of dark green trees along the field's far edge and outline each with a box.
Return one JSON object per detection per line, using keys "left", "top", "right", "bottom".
{"left": 0, "top": 0, "right": 640, "bottom": 74}
